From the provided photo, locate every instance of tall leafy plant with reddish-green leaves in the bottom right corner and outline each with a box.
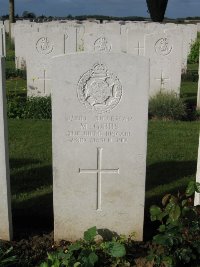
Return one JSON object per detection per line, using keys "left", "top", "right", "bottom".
{"left": 148, "top": 182, "right": 200, "bottom": 267}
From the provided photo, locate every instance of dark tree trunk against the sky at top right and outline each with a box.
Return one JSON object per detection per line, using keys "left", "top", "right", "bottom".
{"left": 146, "top": 0, "right": 168, "bottom": 22}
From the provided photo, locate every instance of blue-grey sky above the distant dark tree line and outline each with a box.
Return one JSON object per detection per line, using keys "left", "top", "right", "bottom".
{"left": 0, "top": 0, "right": 200, "bottom": 18}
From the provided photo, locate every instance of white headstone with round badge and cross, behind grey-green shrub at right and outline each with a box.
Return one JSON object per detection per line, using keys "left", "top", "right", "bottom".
{"left": 145, "top": 29, "right": 182, "bottom": 96}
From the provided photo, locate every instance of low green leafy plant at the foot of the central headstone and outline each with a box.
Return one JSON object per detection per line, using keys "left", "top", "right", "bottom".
{"left": 40, "top": 227, "right": 129, "bottom": 267}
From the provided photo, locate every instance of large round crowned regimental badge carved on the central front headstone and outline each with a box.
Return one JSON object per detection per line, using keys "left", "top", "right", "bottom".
{"left": 77, "top": 63, "right": 122, "bottom": 113}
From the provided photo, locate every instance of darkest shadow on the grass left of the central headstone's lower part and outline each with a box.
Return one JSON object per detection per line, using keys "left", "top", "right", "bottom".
{"left": 12, "top": 193, "right": 53, "bottom": 240}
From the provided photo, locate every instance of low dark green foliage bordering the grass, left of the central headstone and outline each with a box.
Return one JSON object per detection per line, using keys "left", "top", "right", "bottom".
{"left": 7, "top": 96, "right": 51, "bottom": 119}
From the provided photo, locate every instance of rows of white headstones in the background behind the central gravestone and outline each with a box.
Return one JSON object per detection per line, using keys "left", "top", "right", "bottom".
{"left": 11, "top": 21, "right": 197, "bottom": 96}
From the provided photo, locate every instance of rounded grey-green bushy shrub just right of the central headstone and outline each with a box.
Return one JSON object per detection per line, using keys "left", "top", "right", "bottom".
{"left": 149, "top": 92, "right": 186, "bottom": 120}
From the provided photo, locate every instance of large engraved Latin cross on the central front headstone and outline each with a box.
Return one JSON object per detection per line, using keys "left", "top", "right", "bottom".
{"left": 79, "top": 147, "right": 119, "bottom": 211}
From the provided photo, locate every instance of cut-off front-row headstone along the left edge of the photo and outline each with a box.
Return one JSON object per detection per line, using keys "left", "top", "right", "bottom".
{"left": 0, "top": 57, "right": 12, "bottom": 240}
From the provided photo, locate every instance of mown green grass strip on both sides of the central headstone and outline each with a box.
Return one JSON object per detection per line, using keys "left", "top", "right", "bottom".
{"left": 9, "top": 120, "right": 199, "bottom": 239}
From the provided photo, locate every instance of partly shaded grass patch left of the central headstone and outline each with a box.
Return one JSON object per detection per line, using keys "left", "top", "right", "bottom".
{"left": 9, "top": 120, "right": 53, "bottom": 236}
